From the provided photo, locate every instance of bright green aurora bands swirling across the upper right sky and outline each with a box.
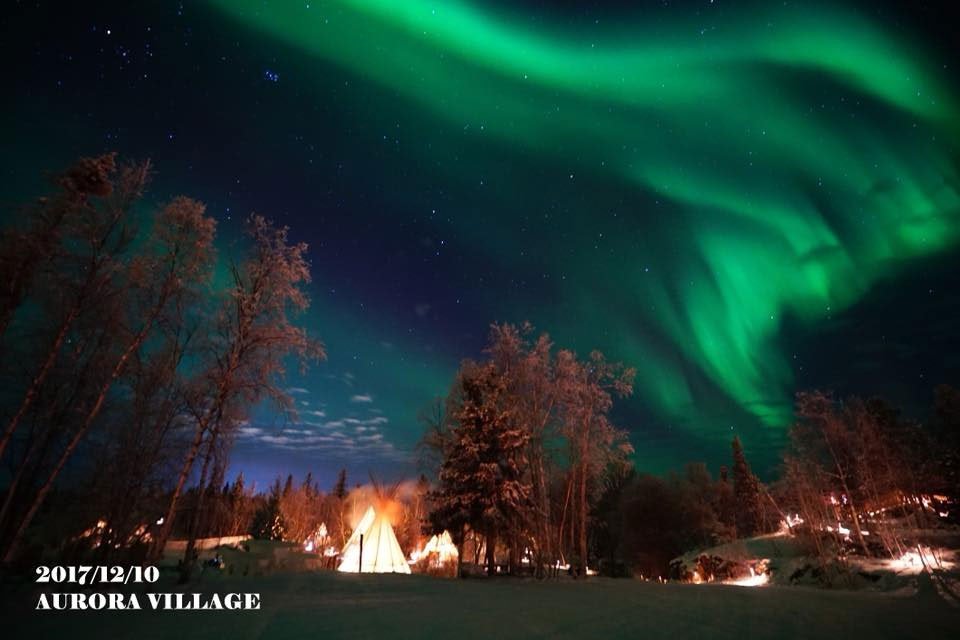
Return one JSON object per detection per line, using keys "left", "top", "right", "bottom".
{"left": 211, "top": 0, "right": 960, "bottom": 436}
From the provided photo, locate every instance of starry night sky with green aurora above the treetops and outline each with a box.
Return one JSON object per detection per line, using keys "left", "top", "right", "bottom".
{"left": 0, "top": 0, "right": 960, "bottom": 490}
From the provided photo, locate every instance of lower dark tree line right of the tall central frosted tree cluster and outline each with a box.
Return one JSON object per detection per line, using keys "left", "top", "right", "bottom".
{"left": 591, "top": 385, "right": 960, "bottom": 581}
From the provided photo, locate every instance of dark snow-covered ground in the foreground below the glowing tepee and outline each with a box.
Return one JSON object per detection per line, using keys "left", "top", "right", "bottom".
{"left": 3, "top": 572, "right": 960, "bottom": 640}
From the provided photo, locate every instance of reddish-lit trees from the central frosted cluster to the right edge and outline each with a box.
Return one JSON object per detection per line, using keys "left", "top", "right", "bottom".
{"left": 419, "top": 324, "right": 960, "bottom": 578}
